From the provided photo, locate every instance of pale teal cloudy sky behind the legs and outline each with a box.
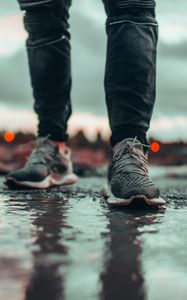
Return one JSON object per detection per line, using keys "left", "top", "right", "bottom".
{"left": 0, "top": 0, "right": 187, "bottom": 139}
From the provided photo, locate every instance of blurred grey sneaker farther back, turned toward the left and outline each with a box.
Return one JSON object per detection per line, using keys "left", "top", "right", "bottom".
{"left": 6, "top": 138, "right": 77, "bottom": 188}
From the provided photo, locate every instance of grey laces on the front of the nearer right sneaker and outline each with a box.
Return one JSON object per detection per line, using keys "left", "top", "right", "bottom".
{"left": 113, "top": 137, "right": 149, "bottom": 175}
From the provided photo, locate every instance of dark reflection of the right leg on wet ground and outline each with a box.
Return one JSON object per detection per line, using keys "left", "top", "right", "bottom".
{"left": 101, "top": 209, "right": 164, "bottom": 300}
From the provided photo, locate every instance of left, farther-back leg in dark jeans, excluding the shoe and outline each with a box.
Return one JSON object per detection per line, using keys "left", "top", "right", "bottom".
{"left": 18, "top": 0, "right": 71, "bottom": 141}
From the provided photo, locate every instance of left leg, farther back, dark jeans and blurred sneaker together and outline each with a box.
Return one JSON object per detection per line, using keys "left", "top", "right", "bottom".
{"left": 6, "top": 0, "right": 77, "bottom": 188}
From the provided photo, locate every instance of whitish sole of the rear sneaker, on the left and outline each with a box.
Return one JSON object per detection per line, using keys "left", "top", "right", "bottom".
{"left": 6, "top": 173, "right": 78, "bottom": 189}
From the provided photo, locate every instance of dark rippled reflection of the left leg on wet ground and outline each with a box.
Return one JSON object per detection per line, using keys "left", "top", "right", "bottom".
{"left": 25, "top": 198, "right": 67, "bottom": 300}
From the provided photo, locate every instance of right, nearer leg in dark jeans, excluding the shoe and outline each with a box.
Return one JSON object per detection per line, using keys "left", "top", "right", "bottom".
{"left": 103, "top": 0, "right": 158, "bottom": 146}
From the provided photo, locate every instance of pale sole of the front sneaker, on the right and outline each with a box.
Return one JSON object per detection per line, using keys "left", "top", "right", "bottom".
{"left": 100, "top": 187, "right": 166, "bottom": 207}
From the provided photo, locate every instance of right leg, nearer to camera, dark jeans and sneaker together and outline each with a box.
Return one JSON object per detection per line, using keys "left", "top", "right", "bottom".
{"left": 103, "top": 0, "right": 165, "bottom": 206}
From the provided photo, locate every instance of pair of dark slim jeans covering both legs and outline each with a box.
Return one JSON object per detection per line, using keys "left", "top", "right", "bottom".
{"left": 18, "top": 0, "right": 158, "bottom": 145}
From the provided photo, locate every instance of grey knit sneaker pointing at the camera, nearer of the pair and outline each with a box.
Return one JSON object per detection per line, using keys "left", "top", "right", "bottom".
{"left": 105, "top": 138, "right": 166, "bottom": 206}
